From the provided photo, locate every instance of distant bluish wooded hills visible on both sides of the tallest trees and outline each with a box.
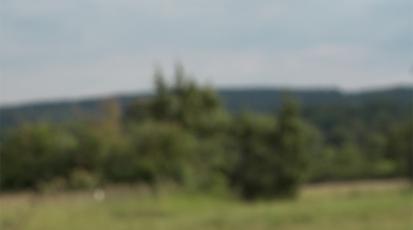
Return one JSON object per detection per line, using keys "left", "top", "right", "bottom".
{"left": 0, "top": 87, "right": 413, "bottom": 135}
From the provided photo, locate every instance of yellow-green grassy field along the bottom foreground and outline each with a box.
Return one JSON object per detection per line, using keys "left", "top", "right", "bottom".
{"left": 0, "top": 181, "right": 413, "bottom": 230}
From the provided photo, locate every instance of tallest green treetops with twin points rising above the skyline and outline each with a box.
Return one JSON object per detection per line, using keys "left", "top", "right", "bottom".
{"left": 128, "top": 65, "right": 230, "bottom": 134}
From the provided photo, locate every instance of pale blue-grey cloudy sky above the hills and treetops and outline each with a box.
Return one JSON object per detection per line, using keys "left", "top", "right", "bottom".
{"left": 0, "top": 0, "right": 413, "bottom": 105}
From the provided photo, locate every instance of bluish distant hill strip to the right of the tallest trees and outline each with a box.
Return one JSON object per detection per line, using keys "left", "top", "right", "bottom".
{"left": 219, "top": 87, "right": 413, "bottom": 112}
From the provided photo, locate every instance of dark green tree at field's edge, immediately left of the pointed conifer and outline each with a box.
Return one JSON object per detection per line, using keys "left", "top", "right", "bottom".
{"left": 231, "top": 114, "right": 277, "bottom": 199}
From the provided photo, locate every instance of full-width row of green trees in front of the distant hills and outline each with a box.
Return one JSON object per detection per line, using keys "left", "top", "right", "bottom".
{"left": 0, "top": 66, "right": 413, "bottom": 199}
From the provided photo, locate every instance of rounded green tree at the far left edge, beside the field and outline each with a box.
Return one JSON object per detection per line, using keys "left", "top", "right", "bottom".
{"left": 0, "top": 124, "right": 76, "bottom": 189}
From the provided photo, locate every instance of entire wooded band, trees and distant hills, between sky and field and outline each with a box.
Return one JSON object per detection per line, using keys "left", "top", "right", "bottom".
{"left": 0, "top": 68, "right": 413, "bottom": 196}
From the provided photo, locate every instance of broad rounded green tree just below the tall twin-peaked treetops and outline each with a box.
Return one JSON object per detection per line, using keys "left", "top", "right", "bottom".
{"left": 108, "top": 122, "right": 196, "bottom": 185}
